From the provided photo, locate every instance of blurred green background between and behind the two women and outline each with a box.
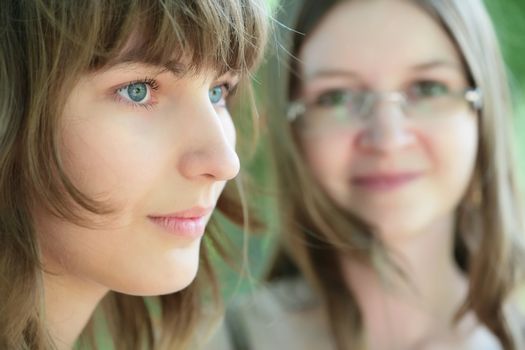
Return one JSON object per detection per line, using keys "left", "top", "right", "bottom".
{"left": 217, "top": 0, "right": 525, "bottom": 299}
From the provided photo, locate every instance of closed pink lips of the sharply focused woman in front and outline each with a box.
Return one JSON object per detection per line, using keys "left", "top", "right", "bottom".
{"left": 148, "top": 207, "right": 213, "bottom": 238}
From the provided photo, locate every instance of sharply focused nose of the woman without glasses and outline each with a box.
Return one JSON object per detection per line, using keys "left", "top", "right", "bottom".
{"left": 179, "top": 101, "right": 240, "bottom": 181}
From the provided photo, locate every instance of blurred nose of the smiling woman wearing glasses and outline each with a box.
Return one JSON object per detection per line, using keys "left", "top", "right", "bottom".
{"left": 357, "top": 101, "right": 416, "bottom": 153}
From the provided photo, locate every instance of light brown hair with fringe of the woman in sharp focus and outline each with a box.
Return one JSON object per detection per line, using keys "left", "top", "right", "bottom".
{"left": 0, "top": 0, "right": 268, "bottom": 349}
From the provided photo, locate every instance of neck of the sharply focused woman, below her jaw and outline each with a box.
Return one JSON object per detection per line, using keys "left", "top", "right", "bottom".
{"left": 44, "top": 272, "right": 107, "bottom": 350}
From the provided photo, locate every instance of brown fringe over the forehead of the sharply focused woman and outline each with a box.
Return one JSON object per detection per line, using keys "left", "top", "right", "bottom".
{"left": 89, "top": 0, "right": 268, "bottom": 75}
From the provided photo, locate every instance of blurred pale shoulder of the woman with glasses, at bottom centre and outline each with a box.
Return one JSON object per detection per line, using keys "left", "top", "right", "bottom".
{"left": 203, "top": 278, "right": 330, "bottom": 350}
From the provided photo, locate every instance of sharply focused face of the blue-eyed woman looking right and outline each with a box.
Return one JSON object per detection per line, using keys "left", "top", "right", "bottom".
{"left": 36, "top": 63, "right": 239, "bottom": 295}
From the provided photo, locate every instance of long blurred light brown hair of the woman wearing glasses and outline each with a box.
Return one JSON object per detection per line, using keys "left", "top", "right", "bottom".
{"left": 267, "top": 0, "right": 525, "bottom": 350}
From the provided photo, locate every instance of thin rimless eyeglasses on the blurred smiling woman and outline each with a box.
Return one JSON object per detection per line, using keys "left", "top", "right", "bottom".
{"left": 287, "top": 82, "right": 483, "bottom": 129}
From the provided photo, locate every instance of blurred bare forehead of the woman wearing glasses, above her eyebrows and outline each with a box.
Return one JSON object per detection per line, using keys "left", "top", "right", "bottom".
{"left": 299, "top": 0, "right": 461, "bottom": 79}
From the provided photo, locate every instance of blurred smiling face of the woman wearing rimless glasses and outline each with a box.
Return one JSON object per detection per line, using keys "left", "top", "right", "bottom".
{"left": 297, "top": 0, "right": 478, "bottom": 239}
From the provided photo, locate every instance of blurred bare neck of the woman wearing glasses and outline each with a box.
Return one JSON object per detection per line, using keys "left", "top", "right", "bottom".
{"left": 342, "top": 218, "right": 468, "bottom": 350}
